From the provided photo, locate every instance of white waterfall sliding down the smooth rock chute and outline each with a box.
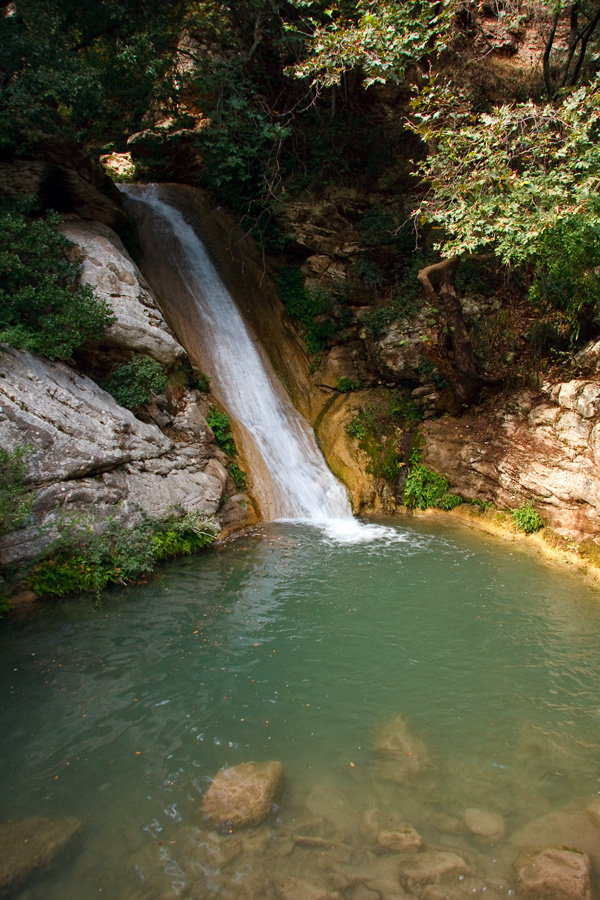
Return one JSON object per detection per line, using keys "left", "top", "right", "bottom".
{"left": 124, "top": 185, "right": 352, "bottom": 522}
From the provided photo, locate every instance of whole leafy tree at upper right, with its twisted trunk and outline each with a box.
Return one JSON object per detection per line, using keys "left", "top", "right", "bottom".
{"left": 296, "top": 0, "right": 600, "bottom": 404}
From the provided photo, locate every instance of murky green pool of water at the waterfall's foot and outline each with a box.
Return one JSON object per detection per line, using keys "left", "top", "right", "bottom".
{"left": 0, "top": 522, "right": 600, "bottom": 900}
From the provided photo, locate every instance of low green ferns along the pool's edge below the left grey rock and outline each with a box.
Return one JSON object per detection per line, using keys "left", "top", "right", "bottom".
{"left": 31, "top": 512, "right": 219, "bottom": 597}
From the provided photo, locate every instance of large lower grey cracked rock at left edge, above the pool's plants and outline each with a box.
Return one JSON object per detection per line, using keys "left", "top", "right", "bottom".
{"left": 0, "top": 345, "right": 227, "bottom": 565}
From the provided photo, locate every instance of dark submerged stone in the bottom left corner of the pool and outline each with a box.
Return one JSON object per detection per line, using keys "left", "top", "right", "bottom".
{"left": 0, "top": 816, "right": 81, "bottom": 896}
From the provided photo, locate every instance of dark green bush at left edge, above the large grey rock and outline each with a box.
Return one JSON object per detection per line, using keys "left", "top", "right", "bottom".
{"left": 0, "top": 201, "right": 114, "bottom": 359}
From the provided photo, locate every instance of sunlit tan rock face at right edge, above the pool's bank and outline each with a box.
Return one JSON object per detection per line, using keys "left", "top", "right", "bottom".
{"left": 422, "top": 380, "right": 600, "bottom": 537}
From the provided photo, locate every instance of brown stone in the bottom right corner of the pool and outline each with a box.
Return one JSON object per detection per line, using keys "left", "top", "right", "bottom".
{"left": 515, "top": 847, "right": 592, "bottom": 900}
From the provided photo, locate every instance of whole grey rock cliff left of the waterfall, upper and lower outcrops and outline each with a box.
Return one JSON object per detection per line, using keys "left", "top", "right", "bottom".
{"left": 0, "top": 211, "right": 252, "bottom": 567}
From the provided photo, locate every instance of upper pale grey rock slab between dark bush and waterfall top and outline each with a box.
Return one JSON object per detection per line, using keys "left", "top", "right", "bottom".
{"left": 61, "top": 222, "right": 185, "bottom": 367}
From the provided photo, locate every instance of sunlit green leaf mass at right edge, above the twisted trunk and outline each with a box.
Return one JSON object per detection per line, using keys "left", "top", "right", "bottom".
{"left": 414, "top": 79, "right": 600, "bottom": 263}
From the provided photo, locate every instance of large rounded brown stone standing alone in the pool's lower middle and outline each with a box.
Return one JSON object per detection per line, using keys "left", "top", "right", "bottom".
{"left": 202, "top": 761, "right": 283, "bottom": 828}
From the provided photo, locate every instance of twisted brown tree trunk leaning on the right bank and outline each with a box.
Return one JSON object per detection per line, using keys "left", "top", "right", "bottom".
{"left": 417, "top": 256, "right": 483, "bottom": 406}
